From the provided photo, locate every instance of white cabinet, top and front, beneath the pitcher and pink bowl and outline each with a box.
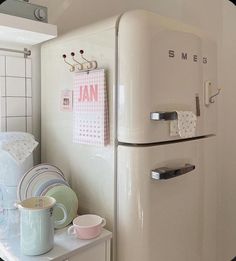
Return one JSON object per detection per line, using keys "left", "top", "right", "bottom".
{"left": 0, "top": 228, "right": 112, "bottom": 261}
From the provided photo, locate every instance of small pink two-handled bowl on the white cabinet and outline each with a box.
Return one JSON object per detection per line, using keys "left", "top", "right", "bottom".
{"left": 68, "top": 214, "right": 106, "bottom": 239}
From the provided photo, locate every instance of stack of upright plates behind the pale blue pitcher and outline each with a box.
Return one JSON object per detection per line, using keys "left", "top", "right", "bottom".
{"left": 17, "top": 164, "right": 78, "bottom": 228}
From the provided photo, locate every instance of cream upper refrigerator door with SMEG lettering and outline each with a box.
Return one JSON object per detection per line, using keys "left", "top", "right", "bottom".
{"left": 118, "top": 11, "right": 218, "bottom": 144}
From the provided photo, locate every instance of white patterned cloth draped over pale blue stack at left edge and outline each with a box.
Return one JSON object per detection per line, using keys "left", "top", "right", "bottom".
{"left": 0, "top": 132, "right": 38, "bottom": 164}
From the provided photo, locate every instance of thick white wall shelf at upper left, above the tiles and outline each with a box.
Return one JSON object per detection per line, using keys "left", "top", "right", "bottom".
{"left": 0, "top": 13, "right": 57, "bottom": 45}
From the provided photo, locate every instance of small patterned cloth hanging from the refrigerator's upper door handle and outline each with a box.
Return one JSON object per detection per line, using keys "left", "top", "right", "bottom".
{"left": 170, "top": 111, "right": 197, "bottom": 138}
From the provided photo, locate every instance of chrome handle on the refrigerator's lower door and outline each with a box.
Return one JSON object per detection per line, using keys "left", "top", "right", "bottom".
{"left": 151, "top": 164, "right": 195, "bottom": 180}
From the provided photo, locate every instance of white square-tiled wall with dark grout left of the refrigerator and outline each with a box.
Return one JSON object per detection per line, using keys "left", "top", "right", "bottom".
{"left": 0, "top": 55, "right": 32, "bottom": 133}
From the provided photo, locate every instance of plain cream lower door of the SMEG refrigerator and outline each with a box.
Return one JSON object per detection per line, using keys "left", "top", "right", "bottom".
{"left": 117, "top": 138, "right": 217, "bottom": 261}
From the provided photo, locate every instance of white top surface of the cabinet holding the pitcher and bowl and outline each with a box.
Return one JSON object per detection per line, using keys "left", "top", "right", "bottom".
{"left": 0, "top": 228, "right": 112, "bottom": 261}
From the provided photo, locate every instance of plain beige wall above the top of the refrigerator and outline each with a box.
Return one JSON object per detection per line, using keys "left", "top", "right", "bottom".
{"left": 31, "top": 0, "right": 222, "bottom": 38}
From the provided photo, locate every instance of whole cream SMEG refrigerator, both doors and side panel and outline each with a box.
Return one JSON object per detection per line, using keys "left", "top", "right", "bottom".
{"left": 42, "top": 10, "right": 217, "bottom": 261}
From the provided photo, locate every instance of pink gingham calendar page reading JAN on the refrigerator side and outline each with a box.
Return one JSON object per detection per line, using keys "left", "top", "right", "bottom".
{"left": 73, "top": 69, "right": 109, "bottom": 146}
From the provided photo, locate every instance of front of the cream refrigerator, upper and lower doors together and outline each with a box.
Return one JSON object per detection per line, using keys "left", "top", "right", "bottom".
{"left": 117, "top": 9, "right": 217, "bottom": 261}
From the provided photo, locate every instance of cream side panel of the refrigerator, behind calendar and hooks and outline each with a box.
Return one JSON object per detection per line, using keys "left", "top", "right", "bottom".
{"left": 41, "top": 19, "right": 115, "bottom": 232}
